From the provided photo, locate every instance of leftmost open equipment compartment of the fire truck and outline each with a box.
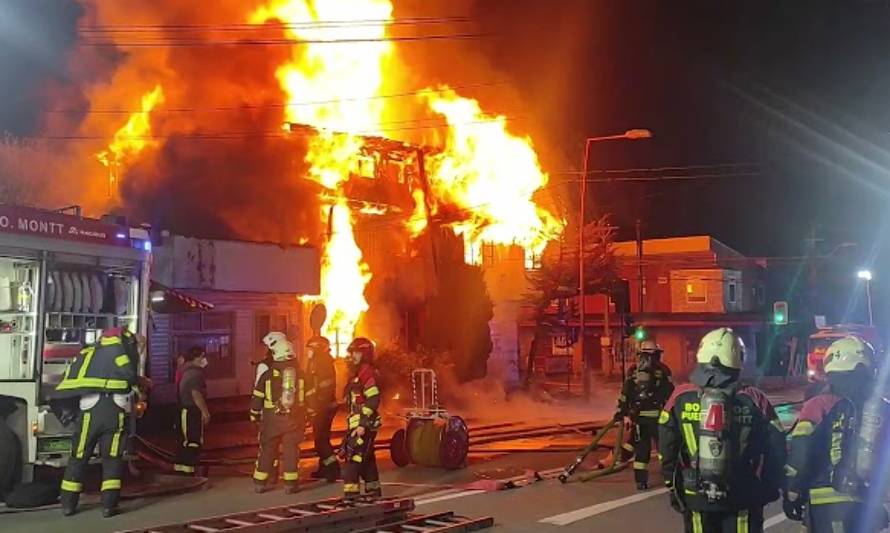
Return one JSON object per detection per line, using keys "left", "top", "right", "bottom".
{"left": 0, "top": 257, "right": 40, "bottom": 381}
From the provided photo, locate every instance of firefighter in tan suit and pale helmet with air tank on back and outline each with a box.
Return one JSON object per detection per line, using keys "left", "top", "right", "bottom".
{"left": 250, "top": 332, "right": 306, "bottom": 494}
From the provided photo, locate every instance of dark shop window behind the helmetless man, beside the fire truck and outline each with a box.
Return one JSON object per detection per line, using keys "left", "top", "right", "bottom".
{"left": 172, "top": 312, "right": 235, "bottom": 379}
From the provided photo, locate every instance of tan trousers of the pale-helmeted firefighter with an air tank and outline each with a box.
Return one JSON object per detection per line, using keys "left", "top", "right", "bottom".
{"left": 253, "top": 410, "right": 305, "bottom": 487}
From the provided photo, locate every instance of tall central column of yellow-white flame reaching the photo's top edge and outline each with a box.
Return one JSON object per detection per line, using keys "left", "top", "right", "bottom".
{"left": 250, "top": 0, "right": 392, "bottom": 355}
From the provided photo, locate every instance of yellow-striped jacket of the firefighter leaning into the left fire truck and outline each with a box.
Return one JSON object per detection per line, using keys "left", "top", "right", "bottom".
{"left": 55, "top": 331, "right": 139, "bottom": 399}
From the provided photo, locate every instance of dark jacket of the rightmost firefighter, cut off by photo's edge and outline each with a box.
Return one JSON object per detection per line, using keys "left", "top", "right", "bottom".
{"left": 785, "top": 392, "right": 859, "bottom": 505}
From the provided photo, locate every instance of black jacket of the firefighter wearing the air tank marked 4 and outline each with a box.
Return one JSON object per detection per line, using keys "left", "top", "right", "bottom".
{"left": 659, "top": 383, "right": 785, "bottom": 512}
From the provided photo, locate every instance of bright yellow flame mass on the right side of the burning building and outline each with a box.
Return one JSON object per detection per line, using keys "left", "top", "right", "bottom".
{"left": 423, "top": 88, "right": 563, "bottom": 264}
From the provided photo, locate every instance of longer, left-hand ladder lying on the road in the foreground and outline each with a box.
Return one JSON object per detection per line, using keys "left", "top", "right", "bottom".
{"left": 117, "top": 498, "right": 416, "bottom": 533}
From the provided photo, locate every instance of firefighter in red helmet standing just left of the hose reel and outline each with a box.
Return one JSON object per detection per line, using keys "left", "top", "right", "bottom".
{"left": 341, "top": 337, "right": 382, "bottom": 502}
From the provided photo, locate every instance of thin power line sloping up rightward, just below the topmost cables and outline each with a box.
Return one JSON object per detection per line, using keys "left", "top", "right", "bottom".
{"left": 44, "top": 80, "right": 513, "bottom": 115}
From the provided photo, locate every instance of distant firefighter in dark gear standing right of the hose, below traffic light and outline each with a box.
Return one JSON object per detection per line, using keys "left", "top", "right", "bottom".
{"left": 615, "top": 340, "right": 674, "bottom": 490}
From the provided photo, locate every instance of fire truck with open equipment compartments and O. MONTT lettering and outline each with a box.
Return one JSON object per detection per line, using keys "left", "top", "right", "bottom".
{"left": 0, "top": 205, "right": 151, "bottom": 480}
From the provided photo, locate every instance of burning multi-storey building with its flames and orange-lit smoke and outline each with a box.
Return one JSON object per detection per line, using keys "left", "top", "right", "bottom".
{"left": 34, "top": 0, "right": 563, "bottom": 382}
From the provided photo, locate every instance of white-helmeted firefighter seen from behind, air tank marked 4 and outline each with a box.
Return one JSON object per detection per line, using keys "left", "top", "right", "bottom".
{"left": 659, "top": 328, "right": 785, "bottom": 533}
